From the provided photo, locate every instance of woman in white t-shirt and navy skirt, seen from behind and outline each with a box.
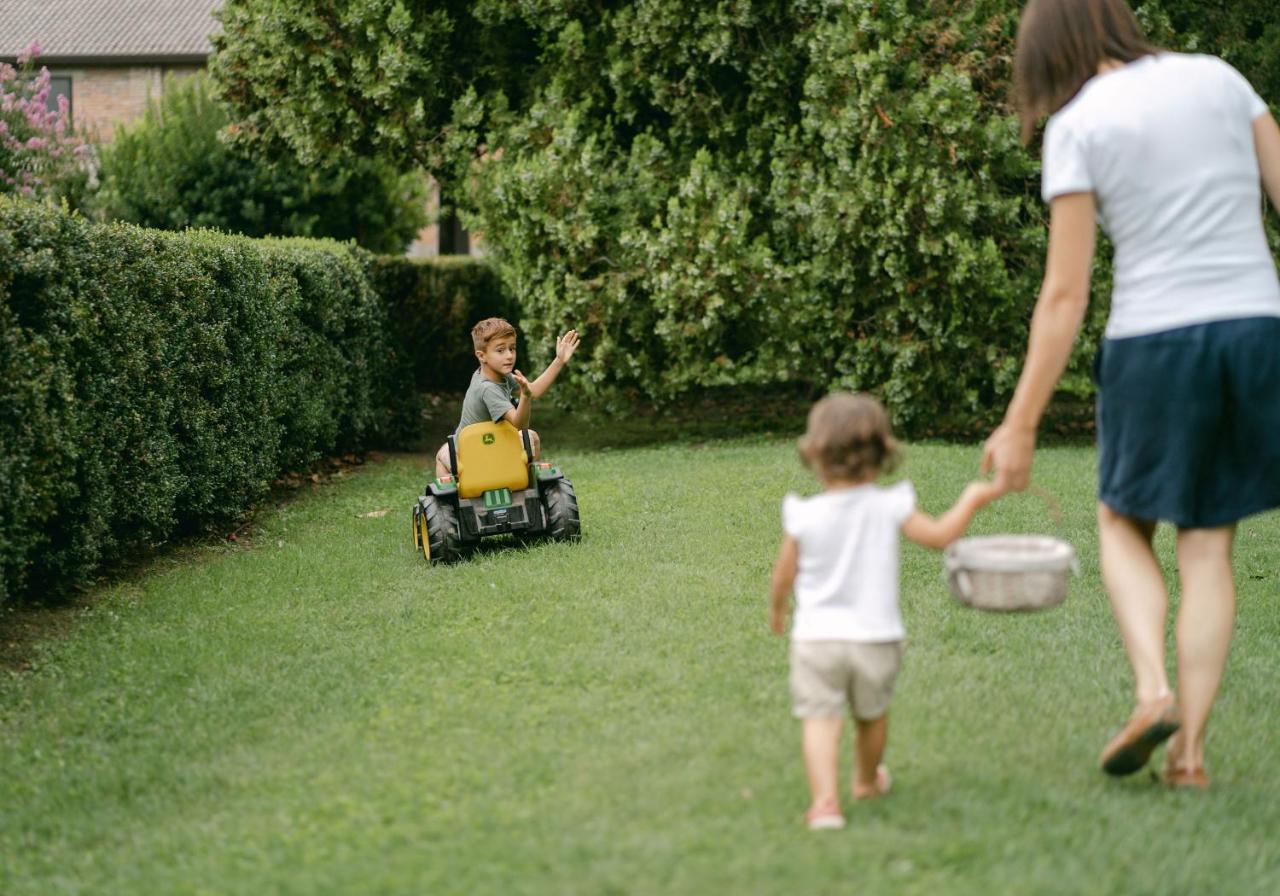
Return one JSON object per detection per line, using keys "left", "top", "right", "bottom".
{"left": 983, "top": 0, "right": 1280, "bottom": 788}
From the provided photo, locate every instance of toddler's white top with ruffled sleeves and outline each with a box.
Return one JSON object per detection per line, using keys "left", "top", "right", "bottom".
{"left": 782, "top": 481, "right": 915, "bottom": 643}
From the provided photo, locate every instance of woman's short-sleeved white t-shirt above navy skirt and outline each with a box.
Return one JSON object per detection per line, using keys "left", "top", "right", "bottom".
{"left": 1041, "top": 52, "right": 1280, "bottom": 339}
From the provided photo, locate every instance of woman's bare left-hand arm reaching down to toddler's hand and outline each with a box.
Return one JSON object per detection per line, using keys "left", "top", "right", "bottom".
{"left": 982, "top": 193, "right": 1097, "bottom": 492}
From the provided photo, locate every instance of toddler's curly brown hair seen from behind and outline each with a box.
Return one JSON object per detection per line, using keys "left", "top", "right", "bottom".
{"left": 799, "top": 392, "right": 901, "bottom": 480}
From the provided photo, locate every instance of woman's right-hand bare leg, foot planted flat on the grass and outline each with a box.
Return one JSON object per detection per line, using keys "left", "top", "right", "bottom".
{"left": 1170, "top": 525, "right": 1235, "bottom": 771}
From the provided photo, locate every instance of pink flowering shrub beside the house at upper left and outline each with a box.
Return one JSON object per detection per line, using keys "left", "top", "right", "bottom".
{"left": 0, "top": 44, "right": 91, "bottom": 200}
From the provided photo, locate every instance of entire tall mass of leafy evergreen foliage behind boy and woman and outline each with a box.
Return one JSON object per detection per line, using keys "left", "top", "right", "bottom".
{"left": 214, "top": 0, "right": 1280, "bottom": 433}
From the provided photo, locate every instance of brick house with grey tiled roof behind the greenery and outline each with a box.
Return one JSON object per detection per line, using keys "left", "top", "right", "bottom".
{"left": 0, "top": 0, "right": 471, "bottom": 256}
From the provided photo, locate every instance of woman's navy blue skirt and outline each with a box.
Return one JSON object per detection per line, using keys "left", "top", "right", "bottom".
{"left": 1094, "top": 317, "right": 1280, "bottom": 529}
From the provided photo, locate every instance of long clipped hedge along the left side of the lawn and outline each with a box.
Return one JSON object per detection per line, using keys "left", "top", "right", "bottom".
{"left": 0, "top": 201, "right": 394, "bottom": 600}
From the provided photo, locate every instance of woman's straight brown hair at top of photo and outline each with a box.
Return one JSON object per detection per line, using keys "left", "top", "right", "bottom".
{"left": 1014, "top": 0, "right": 1156, "bottom": 143}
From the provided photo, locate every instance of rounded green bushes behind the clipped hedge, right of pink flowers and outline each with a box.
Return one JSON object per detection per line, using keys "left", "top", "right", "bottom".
{"left": 96, "top": 76, "right": 426, "bottom": 252}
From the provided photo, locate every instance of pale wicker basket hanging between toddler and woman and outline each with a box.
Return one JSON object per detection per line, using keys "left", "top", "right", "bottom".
{"left": 942, "top": 535, "right": 1080, "bottom": 611}
